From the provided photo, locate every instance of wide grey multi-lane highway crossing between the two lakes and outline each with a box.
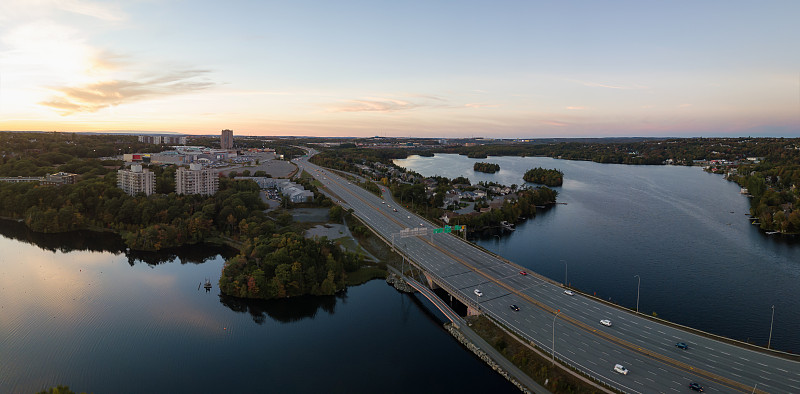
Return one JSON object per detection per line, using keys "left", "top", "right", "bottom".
{"left": 295, "top": 152, "right": 800, "bottom": 393}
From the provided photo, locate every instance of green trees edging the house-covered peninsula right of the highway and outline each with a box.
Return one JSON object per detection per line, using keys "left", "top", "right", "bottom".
{"left": 450, "top": 186, "right": 558, "bottom": 231}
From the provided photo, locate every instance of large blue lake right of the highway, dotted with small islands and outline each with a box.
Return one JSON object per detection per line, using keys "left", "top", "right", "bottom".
{"left": 395, "top": 155, "right": 800, "bottom": 353}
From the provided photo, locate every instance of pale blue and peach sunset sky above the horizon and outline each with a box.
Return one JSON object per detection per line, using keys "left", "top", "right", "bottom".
{"left": 0, "top": 0, "right": 800, "bottom": 138}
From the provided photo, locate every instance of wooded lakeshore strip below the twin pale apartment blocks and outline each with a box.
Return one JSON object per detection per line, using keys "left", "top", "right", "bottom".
{"left": 0, "top": 174, "right": 265, "bottom": 250}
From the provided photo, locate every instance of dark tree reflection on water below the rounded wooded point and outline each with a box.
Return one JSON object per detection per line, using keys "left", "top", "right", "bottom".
{"left": 219, "top": 291, "right": 347, "bottom": 325}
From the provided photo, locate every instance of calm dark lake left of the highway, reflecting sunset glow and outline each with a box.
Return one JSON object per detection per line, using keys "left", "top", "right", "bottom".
{"left": 0, "top": 221, "right": 514, "bottom": 394}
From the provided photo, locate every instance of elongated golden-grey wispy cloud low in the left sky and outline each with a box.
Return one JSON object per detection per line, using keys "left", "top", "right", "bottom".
{"left": 39, "top": 70, "right": 214, "bottom": 115}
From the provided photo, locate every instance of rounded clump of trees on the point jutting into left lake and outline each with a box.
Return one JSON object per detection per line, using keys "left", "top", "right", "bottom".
{"left": 219, "top": 233, "right": 363, "bottom": 299}
